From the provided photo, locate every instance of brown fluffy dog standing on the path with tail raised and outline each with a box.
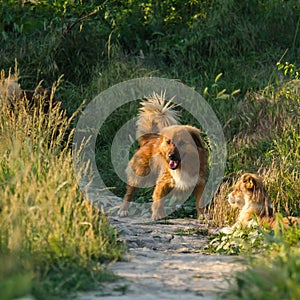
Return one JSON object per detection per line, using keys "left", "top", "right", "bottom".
{"left": 119, "top": 94, "right": 207, "bottom": 220}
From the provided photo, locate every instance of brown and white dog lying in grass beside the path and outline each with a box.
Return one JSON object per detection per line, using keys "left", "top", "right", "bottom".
{"left": 228, "top": 173, "right": 299, "bottom": 227}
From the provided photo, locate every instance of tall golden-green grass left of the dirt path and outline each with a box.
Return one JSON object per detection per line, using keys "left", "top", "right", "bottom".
{"left": 0, "top": 73, "right": 123, "bottom": 299}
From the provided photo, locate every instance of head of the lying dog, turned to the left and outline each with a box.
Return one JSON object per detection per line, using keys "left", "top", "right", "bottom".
{"left": 228, "top": 173, "right": 262, "bottom": 209}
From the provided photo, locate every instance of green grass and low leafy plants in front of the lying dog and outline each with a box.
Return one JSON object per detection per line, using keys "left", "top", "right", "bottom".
{"left": 201, "top": 214, "right": 300, "bottom": 300}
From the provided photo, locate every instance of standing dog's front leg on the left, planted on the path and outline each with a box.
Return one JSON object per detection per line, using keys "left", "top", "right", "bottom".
{"left": 152, "top": 178, "right": 174, "bottom": 220}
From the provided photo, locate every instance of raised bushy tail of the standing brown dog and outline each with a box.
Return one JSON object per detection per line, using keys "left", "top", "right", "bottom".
{"left": 136, "top": 92, "right": 179, "bottom": 139}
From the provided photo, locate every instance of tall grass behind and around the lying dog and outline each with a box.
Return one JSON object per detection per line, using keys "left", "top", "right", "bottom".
{"left": 211, "top": 79, "right": 300, "bottom": 226}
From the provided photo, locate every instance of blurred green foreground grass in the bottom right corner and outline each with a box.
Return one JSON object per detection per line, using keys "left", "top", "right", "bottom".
{"left": 223, "top": 221, "right": 300, "bottom": 300}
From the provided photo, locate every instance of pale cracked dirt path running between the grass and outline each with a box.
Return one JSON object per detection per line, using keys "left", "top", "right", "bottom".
{"left": 78, "top": 218, "right": 243, "bottom": 300}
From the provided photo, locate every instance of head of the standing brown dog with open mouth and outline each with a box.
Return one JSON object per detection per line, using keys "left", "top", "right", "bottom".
{"left": 160, "top": 126, "right": 200, "bottom": 172}
